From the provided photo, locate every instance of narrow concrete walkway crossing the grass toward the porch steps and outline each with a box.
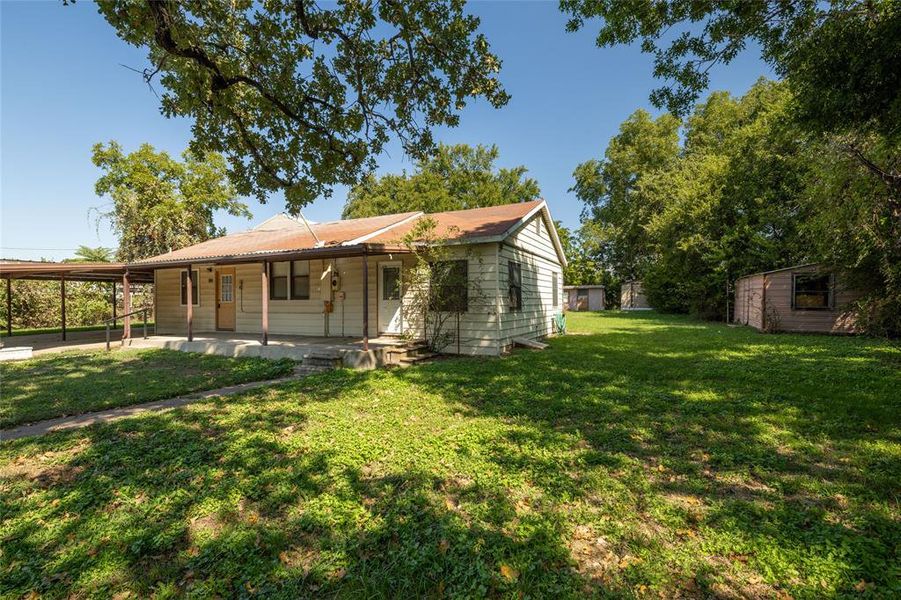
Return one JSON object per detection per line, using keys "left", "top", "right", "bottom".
{"left": 0, "top": 367, "right": 306, "bottom": 441}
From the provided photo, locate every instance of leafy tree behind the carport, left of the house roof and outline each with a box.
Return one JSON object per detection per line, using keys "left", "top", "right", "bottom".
{"left": 93, "top": 142, "right": 251, "bottom": 262}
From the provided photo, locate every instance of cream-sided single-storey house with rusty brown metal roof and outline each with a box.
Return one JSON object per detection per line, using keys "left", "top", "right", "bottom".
{"left": 133, "top": 200, "right": 566, "bottom": 355}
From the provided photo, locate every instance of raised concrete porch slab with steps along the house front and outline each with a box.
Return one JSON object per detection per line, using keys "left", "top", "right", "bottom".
{"left": 126, "top": 332, "right": 419, "bottom": 369}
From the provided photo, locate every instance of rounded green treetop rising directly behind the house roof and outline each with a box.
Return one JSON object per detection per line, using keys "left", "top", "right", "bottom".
{"left": 343, "top": 144, "right": 541, "bottom": 219}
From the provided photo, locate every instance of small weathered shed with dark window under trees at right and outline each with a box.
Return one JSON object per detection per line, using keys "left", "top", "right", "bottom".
{"left": 732, "top": 264, "right": 860, "bottom": 333}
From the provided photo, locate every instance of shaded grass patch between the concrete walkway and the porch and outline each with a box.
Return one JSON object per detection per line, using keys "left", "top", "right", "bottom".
{"left": 0, "top": 350, "right": 294, "bottom": 428}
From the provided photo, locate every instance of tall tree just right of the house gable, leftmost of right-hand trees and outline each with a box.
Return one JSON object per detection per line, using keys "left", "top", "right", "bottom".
{"left": 570, "top": 110, "right": 680, "bottom": 278}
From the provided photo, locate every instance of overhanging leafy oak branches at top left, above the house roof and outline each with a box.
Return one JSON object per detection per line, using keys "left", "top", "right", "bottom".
{"left": 97, "top": 0, "right": 509, "bottom": 210}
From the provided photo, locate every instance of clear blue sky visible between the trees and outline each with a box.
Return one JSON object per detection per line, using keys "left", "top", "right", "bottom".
{"left": 0, "top": 1, "right": 771, "bottom": 259}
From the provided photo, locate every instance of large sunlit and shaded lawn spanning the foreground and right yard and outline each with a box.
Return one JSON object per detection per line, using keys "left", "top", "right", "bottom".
{"left": 0, "top": 313, "right": 901, "bottom": 598}
